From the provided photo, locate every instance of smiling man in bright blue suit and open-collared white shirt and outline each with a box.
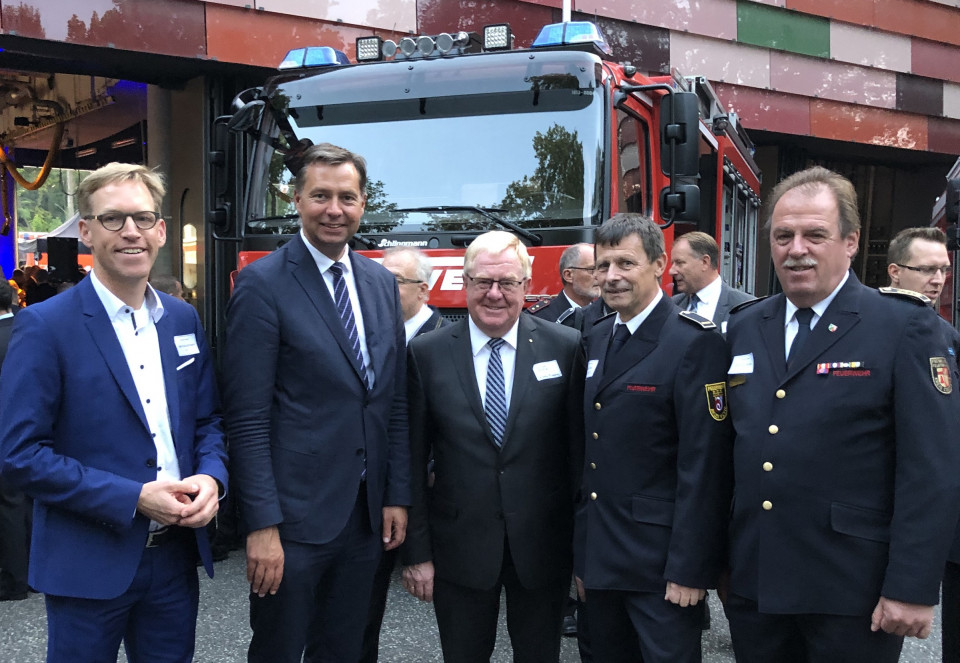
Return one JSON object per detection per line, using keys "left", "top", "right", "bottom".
{"left": 0, "top": 163, "right": 227, "bottom": 662}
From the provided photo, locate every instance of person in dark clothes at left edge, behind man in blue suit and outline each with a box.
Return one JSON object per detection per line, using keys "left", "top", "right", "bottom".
{"left": 0, "top": 282, "right": 30, "bottom": 601}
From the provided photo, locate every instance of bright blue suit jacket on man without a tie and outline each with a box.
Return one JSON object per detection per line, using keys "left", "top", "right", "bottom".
{"left": 0, "top": 279, "right": 227, "bottom": 599}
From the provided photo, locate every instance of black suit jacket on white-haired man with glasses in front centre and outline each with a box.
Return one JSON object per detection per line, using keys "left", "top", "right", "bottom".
{"left": 402, "top": 315, "right": 584, "bottom": 589}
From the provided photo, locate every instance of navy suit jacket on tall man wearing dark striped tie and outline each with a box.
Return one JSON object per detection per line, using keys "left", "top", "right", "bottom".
{"left": 223, "top": 235, "right": 410, "bottom": 544}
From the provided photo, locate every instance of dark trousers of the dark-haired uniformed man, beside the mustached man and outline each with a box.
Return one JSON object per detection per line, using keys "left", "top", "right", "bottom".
{"left": 587, "top": 589, "right": 704, "bottom": 663}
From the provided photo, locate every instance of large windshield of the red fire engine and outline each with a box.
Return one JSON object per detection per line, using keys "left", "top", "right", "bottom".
{"left": 247, "top": 53, "right": 604, "bottom": 239}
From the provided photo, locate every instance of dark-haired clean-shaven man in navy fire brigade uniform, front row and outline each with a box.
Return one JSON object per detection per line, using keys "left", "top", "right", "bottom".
{"left": 576, "top": 214, "right": 733, "bottom": 663}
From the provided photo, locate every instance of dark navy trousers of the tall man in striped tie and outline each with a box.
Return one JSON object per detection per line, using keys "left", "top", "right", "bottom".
{"left": 247, "top": 485, "right": 383, "bottom": 663}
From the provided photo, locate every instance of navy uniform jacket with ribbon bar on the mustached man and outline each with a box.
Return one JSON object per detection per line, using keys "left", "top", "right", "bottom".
{"left": 727, "top": 272, "right": 960, "bottom": 616}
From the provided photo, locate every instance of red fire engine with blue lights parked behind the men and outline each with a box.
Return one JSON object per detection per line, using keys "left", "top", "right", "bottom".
{"left": 207, "top": 22, "right": 760, "bottom": 350}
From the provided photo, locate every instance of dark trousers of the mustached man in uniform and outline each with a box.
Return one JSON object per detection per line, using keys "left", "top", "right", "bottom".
{"left": 724, "top": 594, "right": 903, "bottom": 663}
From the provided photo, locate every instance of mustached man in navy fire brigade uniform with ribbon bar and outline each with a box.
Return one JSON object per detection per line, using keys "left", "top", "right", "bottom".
{"left": 725, "top": 167, "right": 960, "bottom": 663}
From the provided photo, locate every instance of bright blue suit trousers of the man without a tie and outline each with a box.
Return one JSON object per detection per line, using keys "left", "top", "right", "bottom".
{"left": 46, "top": 530, "right": 200, "bottom": 663}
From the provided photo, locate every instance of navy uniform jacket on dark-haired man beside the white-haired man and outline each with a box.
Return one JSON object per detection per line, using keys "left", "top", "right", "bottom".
{"left": 576, "top": 296, "right": 733, "bottom": 592}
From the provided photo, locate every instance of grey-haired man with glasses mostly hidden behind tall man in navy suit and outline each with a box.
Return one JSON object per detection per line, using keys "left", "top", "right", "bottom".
{"left": 360, "top": 246, "right": 447, "bottom": 663}
